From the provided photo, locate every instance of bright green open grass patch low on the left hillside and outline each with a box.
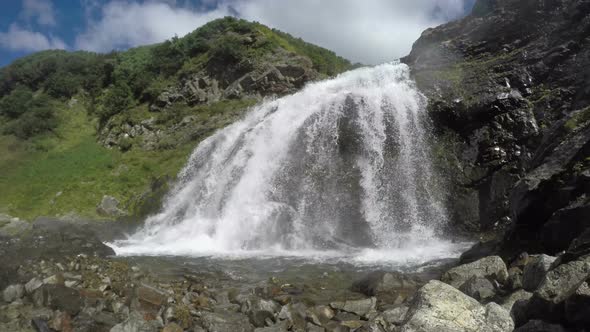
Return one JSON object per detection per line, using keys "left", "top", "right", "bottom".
{"left": 0, "top": 101, "right": 194, "bottom": 218}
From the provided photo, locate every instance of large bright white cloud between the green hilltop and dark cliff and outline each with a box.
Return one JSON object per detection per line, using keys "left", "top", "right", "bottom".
{"left": 233, "top": 0, "right": 464, "bottom": 64}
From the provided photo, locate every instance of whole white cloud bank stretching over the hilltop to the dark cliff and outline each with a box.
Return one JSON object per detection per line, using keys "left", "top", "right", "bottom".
{"left": 76, "top": 0, "right": 468, "bottom": 64}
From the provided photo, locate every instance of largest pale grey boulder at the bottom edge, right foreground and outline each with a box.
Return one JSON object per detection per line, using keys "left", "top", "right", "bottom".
{"left": 401, "top": 280, "right": 514, "bottom": 332}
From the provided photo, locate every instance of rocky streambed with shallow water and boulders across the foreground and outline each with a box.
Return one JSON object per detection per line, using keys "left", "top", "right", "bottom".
{"left": 0, "top": 219, "right": 590, "bottom": 332}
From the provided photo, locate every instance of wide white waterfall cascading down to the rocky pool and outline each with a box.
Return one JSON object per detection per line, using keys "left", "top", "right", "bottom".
{"left": 111, "top": 63, "right": 464, "bottom": 260}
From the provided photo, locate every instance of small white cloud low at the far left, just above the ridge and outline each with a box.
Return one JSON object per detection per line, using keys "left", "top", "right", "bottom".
{"left": 0, "top": 24, "right": 66, "bottom": 51}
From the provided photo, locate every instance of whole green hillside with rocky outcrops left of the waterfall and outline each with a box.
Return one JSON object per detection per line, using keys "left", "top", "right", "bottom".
{"left": 0, "top": 17, "right": 352, "bottom": 222}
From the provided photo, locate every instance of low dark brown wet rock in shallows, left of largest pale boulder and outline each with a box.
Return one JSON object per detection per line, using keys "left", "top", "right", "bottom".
{"left": 353, "top": 271, "right": 419, "bottom": 304}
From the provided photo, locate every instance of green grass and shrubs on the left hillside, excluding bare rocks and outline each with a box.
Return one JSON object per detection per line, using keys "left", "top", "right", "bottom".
{"left": 0, "top": 19, "right": 351, "bottom": 219}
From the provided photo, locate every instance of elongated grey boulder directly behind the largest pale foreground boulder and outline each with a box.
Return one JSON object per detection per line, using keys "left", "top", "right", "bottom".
{"left": 442, "top": 256, "right": 508, "bottom": 288}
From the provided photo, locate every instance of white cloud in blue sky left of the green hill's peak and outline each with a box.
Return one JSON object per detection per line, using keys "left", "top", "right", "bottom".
{"left": 76, "top": 1, "right": 235, "bottom": 51}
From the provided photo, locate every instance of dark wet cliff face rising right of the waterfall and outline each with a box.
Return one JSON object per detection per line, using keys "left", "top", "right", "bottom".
{"left": 403, "top": 0, "right": 590, "bottom": 254}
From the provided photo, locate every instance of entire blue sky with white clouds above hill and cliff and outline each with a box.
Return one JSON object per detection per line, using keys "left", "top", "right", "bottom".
{"left": 0, "top": 0, "right": 475, "bottom": 66}
